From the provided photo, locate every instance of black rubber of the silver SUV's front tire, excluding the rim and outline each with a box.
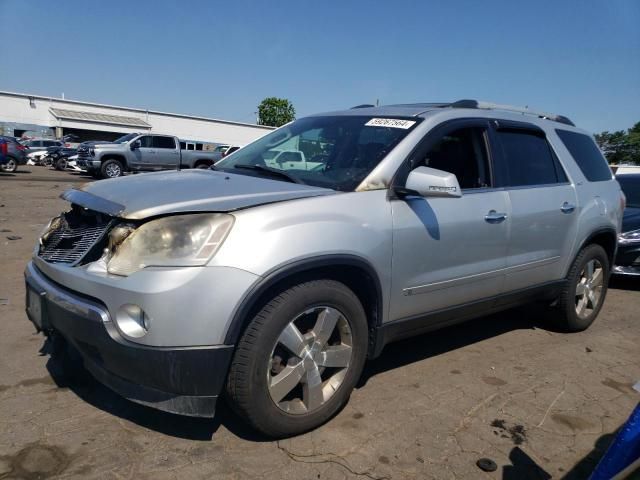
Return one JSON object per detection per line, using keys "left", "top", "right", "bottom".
{"left": 226, "top": 280, "right": 368, "bottom": 438}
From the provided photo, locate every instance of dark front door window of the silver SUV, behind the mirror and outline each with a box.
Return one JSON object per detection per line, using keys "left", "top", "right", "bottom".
{"left": 413, "top": 128, "right": 491, "bottom": 188}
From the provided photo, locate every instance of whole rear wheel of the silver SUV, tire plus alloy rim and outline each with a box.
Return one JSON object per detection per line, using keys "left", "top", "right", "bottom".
{"left": 554, "top": 244, "right": 610, "bottom": 332}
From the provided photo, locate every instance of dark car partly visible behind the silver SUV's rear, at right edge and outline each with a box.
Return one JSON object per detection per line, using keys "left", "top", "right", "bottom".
{"left": 613, "top": 172, "right": 640, "bottom": 276}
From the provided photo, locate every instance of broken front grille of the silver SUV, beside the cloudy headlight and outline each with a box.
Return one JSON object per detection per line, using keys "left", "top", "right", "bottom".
{"left": 38, "top": 206, "right": 110, "bottom": 264}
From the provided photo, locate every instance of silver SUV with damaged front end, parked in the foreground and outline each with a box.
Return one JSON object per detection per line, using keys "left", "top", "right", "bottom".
{"left": 25, "top": 100, "right": 624, "bottom": 437}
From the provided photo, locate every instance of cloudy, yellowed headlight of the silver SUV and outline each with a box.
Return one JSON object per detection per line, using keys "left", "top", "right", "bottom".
{"left": 107, "top": 213, "right": 234, "bottom": 276}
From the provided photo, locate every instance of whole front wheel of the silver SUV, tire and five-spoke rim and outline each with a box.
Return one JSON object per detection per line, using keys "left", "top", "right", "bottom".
{"left": 227, "top": 280, "right": 368, "bottom": 438}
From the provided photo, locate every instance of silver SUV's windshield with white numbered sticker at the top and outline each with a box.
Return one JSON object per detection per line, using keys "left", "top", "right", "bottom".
{"left": 215, "top": 115, "right": 420, "bottom": 192}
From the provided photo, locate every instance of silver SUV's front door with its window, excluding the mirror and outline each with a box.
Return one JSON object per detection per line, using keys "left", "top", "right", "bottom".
{"left": 389, "top": 120, "right": 510, "bottom": 321}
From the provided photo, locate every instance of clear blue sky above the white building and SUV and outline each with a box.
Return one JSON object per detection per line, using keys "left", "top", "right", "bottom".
{"left": 0, "top": 0, "right": 640, "bottom": 132}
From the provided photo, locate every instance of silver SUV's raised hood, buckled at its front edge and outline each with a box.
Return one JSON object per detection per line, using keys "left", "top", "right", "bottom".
{"left": 61, "top": 169, "right": 336, "bottom": 219}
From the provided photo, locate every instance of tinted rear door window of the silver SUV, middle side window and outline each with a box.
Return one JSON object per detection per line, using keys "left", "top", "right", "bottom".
{"left": 498, "top": 130, "right": 565, "bottom": 187}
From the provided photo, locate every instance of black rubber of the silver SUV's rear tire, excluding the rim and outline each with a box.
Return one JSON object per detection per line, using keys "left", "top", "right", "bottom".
{"left": 552, "top": 244, "right": 610, "bottom": 332}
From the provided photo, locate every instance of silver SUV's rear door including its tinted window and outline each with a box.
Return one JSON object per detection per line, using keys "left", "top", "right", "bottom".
{"left": 493, "top": 120, "right": 578, "bottom": 291}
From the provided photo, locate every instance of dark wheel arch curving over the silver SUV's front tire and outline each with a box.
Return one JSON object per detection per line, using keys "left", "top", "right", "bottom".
{"left": 224, "top": 255, "right": 383, "bottom": 353}
